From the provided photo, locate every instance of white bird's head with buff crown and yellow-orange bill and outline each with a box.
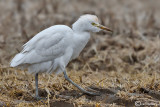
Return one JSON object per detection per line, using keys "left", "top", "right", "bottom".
{"left": 73, "top": 14, "right": 112, "bottom": 32}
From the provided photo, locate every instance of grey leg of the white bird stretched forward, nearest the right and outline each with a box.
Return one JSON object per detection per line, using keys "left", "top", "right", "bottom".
{"left": 63, "top": 70, "right": 100, "bottom": 95}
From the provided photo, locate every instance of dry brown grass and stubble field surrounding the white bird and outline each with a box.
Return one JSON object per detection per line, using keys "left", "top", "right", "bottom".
{"left": 0, "top": 0, "right": 160, "bottom": 107}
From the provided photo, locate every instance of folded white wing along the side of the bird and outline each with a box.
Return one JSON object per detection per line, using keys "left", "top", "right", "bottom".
{"left": 17, "top": 26, "right": 73, "bottom": 64}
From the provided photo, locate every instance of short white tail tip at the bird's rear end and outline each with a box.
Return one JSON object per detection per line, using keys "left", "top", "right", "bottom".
{"left": 10, "top": 53, "right": 25, "bottom": 67}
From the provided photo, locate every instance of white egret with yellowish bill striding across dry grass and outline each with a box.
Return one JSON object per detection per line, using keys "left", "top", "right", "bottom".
{"left": 10, "top": 14, "right": 112, "bottom": 99}
